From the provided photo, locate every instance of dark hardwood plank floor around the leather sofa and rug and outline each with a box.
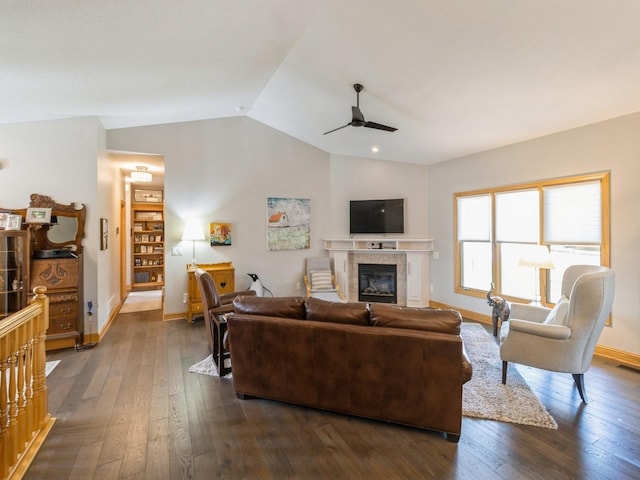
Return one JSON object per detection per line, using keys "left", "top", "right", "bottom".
{"left": 25, "top": 311, "right": 640, "bottom": 480}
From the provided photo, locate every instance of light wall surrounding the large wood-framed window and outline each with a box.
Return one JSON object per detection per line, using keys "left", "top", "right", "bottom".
{"left": 428, "top": 113, "right": 640, "bottom": 354}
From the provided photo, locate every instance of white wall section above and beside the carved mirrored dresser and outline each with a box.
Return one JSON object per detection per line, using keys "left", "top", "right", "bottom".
{"left": 0, "top": 117, "right": 104, "bottom": 338}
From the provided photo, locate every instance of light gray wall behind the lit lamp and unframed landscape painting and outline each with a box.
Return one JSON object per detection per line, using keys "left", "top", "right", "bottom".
{"left": 107, "top": 117, "right": 330, "bottom": 315}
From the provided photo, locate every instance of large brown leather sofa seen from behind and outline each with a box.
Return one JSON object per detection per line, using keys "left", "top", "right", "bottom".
{"left": 227, "top": 297, "right": 472, "bottom": 442}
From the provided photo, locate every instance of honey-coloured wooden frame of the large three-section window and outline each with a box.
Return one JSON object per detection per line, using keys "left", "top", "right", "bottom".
{"left": 453, "top": 171, "right": 611, "bottom": 306}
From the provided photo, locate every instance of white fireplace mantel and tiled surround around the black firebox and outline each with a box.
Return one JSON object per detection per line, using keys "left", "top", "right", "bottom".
{"left": 324, "top": 238, "right": 434, "bottom": 307}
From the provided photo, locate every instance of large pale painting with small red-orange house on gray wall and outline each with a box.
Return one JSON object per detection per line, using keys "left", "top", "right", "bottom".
{"left": 267, "top": 197, "right": 311, "bottom": 250}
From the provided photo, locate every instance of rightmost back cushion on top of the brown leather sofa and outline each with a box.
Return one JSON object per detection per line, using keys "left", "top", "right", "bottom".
{"left": 369, "top": 303, "right": 462, "bottom": 335}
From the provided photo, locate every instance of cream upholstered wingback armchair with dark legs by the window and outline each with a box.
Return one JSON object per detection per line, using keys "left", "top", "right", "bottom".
{"left": 500, "top": 265, "right": 615, "bottom": 403}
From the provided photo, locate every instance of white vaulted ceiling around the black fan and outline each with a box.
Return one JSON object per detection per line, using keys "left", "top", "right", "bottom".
{"left": 0, "top": 0, "right": 640, "bottom": 164}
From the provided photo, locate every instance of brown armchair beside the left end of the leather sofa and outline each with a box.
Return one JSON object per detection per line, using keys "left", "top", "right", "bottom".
{"left": 195, "top": 268, "right": 256, "bottom": 377}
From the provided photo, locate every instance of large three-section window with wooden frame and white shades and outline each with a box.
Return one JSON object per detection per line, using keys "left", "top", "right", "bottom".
{"left": 454, "top": 172, "right": 609, "bottom": 304}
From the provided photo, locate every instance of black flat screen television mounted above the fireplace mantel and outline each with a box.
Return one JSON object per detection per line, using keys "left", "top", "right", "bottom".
{"left": 349, "top": 198, "right": 404, "bottom": 235}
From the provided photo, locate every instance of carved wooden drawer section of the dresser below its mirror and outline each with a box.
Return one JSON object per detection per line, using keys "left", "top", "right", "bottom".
{"left": 30, "top": 255, "right": 84, "bottom": 350}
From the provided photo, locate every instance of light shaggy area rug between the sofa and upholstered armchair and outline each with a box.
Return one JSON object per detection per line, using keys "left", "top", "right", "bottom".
{"left": 462, "top": 322, "right": 558, "bottom": 430}
